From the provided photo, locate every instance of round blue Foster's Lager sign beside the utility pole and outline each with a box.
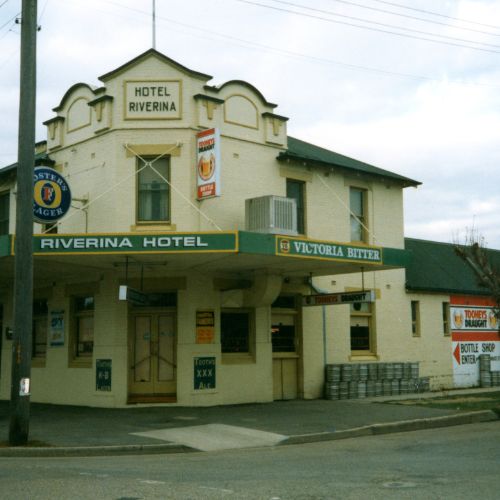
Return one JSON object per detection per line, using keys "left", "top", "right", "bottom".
{"left": 33, "top": 167, "right": 71, "bottom": 224}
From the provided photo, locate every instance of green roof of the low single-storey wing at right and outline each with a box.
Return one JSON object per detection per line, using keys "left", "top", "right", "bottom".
{"left": 405, "top": 238, "right": 500, "bottom": 295}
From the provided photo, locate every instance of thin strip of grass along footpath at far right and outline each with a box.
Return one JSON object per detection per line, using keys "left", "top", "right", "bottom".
{"left": 387, "top": 391, "right": 500, "bottom": 416}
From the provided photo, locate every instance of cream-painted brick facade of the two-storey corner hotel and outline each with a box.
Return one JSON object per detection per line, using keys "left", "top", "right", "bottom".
{"left": 0, "top": 50, "right": 446, "bottom": 407}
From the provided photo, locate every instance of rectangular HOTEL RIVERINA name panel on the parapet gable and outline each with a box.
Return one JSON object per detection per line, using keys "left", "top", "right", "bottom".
{"left": 124, "top": 80, "right": 182, "bottom": 120}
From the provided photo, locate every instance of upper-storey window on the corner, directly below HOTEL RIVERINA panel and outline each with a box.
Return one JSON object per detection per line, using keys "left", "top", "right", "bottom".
{"left": 137, "top": 157, "right": 170, "bottom": 223}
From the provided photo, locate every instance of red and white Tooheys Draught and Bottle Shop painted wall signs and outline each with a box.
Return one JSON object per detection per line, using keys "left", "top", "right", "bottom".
{"left": 450, "top": 296, "right": 500, "bottom": 387}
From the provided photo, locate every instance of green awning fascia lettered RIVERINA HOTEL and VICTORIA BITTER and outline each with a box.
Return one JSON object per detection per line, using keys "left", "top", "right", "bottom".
{"left": 0, "top": 231, "right": 392, "bottom": 267}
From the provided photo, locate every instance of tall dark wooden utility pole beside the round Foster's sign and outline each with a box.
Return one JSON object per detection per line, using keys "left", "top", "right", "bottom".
{"left": 9, "top": 0, "right": 37, "bottom": 446}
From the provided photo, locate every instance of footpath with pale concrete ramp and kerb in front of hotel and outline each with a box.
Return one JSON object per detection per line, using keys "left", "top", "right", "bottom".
{"left": 0, "top": 387, "right": 499, "bottom": 457}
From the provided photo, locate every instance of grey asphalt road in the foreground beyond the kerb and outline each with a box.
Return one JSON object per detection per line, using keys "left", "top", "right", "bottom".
{"left": 0, "top": 422, "right": 500, "bottom": 500}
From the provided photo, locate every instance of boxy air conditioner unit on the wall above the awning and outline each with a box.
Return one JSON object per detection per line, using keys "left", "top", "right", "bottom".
{"left": 245, "top": 195, "right": 298, "bottom": 236}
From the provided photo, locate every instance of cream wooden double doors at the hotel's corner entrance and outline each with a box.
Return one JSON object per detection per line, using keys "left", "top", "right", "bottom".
{"left": 129, "top": 311, "right": 177, "bottom": 402}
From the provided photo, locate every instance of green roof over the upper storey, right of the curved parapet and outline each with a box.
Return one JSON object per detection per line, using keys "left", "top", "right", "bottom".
{"left": 278, "top": 136, "right": 421, "bottom": 187}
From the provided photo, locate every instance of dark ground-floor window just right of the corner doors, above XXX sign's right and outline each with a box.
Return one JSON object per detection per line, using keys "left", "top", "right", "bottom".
{"left": 220, "top": 310, "right": 252, "bottom": 354}
